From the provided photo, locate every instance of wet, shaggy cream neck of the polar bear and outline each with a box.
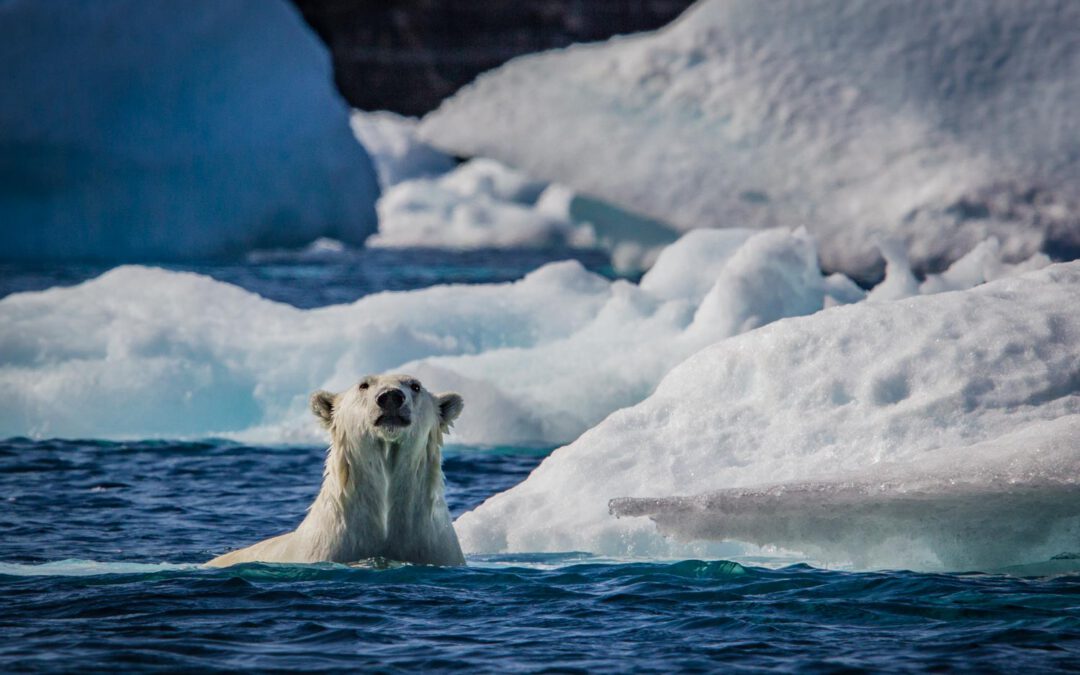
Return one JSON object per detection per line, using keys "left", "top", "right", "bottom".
{"left": 297, "top": 428, "right": 448, "bottom": 561}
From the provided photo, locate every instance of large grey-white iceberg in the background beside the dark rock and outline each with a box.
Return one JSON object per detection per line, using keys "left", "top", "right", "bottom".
{"left": 421, "top": 0, "right": 1080, "bottom": 280}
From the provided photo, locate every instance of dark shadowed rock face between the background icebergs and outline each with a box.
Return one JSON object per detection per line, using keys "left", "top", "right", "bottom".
{"left": 293, "top": 0, "right": 692, "bottom": 116}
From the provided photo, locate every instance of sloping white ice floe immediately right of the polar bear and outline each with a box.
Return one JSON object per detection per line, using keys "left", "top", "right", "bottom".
{"left": 457, "top": 262, "right": 1080, "bottom": 569}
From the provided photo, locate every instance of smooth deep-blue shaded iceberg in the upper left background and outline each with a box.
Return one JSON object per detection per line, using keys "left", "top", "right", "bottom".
{"left": 0, "top": 0, "right": 378, "bottom": 260}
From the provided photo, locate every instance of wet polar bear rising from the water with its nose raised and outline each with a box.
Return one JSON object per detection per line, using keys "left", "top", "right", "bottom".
{"left": 206, "top": 375, "right": 464, "bottom": 567}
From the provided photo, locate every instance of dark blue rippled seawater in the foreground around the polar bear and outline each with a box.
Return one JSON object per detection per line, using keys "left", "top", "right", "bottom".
{"left": 0, "top": 440, "right": 1080, "bottom": 672}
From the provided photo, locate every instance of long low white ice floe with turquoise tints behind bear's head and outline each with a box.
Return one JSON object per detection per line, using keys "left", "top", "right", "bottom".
{"left": 0, "top": 228, "right": 861, "bottom": 444}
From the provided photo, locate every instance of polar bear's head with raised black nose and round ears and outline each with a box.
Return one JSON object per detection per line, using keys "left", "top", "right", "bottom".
{"left": 311, "top": 375, "right": 463, "bottom": 446}
